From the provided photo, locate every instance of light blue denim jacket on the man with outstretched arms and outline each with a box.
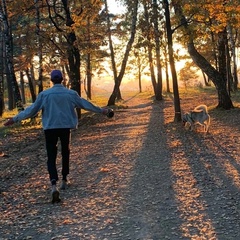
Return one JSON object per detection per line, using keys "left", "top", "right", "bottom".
{"left": 13, "top": 84, "right": 103, "bottom": 130}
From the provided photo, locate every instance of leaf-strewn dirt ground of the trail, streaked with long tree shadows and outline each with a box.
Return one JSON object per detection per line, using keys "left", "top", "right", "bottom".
{"left": 0, "top": 91, "right": 240, "bottom": 240}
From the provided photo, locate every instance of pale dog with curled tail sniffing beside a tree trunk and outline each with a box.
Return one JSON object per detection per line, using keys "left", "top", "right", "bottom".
{"left": 182, "top": 105, "right": 210, "bottom": 132}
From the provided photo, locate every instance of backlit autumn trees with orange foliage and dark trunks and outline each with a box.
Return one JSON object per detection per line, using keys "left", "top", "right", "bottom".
{"left": 0, "top": 0, "right": 240, "bottom": 116}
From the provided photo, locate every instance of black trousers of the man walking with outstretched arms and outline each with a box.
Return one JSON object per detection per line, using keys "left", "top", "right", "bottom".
{"left": 44, "top": 128, "right": 71, "bottom": 181}
